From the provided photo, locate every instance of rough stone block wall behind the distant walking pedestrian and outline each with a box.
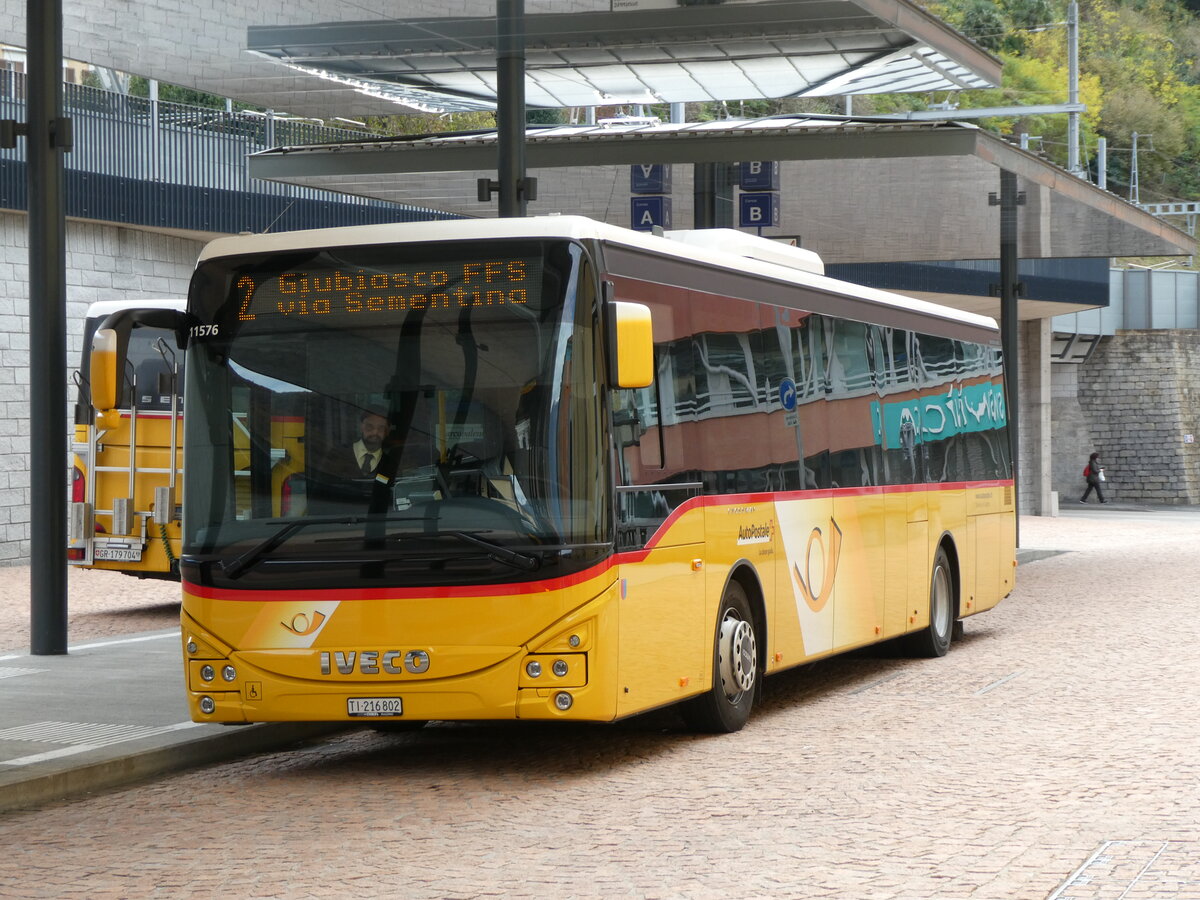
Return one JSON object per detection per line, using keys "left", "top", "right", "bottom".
{"left": 1054, "top": 330, "right": 1200, "bottom": 504}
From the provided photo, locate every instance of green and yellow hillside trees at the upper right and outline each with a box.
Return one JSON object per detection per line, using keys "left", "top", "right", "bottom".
{"left": 931, "top": 0, "right": 1200, "bottom": 202}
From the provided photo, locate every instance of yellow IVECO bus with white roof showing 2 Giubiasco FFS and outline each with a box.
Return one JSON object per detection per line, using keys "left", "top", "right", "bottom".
{"left": 97, "top": 216, "right": 1015, "bottom": 731}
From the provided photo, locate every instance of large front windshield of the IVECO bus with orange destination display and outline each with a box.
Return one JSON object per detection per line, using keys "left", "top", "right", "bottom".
{"left": 182, "top": 240, "right": 612, "bottom": 588}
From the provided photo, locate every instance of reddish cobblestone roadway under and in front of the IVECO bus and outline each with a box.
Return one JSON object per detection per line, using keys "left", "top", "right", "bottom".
{"left": 0, "top": 506, "right": 1200, "bottom": 900}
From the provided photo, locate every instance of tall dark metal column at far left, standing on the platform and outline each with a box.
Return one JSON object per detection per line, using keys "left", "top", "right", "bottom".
{"left": 25, "top": 0, "right": 71, "bottom": 655}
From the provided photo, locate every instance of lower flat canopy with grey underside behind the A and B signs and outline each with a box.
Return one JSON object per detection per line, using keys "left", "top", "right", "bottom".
{"left": 250, "top": 116, "right": 1195, "bottom": 263}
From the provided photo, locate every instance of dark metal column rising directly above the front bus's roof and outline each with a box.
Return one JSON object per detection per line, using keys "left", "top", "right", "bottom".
{"left": 496, "top": 0, "right": 528, "bottom": 217}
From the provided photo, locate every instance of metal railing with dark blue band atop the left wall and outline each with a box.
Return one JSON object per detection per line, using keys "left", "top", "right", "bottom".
{"left": 0, "top": 71, "right": 454, "bottom": 234}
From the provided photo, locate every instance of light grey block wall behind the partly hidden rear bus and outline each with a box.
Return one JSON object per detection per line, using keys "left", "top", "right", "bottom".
{"left": 0, "top": 212, "right": 203, "bottom": 565}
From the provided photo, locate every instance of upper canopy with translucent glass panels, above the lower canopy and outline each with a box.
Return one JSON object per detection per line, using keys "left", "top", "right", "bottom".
{"left": 247, "top": 0, "right": 1000, "bottom": 112}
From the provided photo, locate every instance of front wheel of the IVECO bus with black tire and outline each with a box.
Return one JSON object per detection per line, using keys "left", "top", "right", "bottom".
{"left": 682, "top": 581, "right": 761, "bottom": 734}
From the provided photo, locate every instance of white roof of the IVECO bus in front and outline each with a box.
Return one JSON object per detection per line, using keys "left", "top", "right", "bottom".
{"left": 198, "top": 216, "right": 998, "bottom": 332}
